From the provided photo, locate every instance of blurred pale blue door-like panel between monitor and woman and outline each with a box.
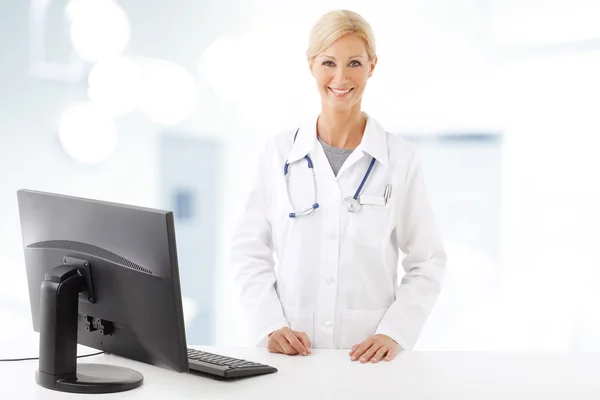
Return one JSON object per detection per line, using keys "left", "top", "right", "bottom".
{"left": 159, "top": 132, "right": 222, "bottom": 345}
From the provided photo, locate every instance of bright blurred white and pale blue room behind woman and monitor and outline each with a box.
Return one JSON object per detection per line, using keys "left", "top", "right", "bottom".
{"left": 0, "top": 0, "right": 600, "bottom": 358}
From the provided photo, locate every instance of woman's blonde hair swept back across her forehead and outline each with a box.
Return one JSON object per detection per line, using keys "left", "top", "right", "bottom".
{"left": 306, "top": 10, "right": 376, "bottom": 62}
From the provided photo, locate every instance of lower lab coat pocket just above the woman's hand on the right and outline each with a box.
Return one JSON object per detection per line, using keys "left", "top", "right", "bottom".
{"left": 340, "top": 308, "right": 387, "bottom": 349}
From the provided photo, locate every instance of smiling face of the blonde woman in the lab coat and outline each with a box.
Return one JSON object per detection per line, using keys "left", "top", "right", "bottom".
{"left": 310, "top": 34, "right": 377, "bottom": 111}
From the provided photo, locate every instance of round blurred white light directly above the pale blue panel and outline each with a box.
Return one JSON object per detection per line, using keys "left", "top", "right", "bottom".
{"left": 140, "top": 58, "right": 197, "bottom": 125}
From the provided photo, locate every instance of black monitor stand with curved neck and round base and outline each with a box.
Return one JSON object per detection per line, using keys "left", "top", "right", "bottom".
{"left": 35, "top": 257, "right": 144, "bottom": 393}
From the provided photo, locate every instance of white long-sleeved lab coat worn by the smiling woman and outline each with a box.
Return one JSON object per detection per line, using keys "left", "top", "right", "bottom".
{"left": 232, "top": 111, "right": 446, "bottom": 350}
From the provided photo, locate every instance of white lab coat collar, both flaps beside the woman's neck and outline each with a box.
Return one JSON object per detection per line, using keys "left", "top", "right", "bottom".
{"left": 288, "top": 113, "right": 389, "bottom": 167}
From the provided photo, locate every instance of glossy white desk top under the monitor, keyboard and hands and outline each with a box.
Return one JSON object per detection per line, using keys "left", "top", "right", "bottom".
{"left": 0, "top": 347, "right": 600, "bottom": 400}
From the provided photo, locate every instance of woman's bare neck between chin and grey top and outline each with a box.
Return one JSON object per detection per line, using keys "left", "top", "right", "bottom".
{"left": 317, "top": 104, "right": 367, "bottom": 149}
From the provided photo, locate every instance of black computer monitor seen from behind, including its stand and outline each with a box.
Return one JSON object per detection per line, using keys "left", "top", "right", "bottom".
{"left": 17, "top": 190, "right": 188, "bottom": 393}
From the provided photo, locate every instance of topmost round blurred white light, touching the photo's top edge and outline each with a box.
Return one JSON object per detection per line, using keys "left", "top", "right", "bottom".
{"left": 66, "top": 0, "right": 130, "bottom": 62}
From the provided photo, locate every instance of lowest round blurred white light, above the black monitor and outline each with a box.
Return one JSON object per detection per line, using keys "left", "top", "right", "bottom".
{"left": 59, "top": 102, "right": 117, "bottom": 165}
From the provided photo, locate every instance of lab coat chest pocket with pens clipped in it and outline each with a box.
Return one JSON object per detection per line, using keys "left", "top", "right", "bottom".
{"left": 348, "top": 197, "right": 395, "bottom": 246}
